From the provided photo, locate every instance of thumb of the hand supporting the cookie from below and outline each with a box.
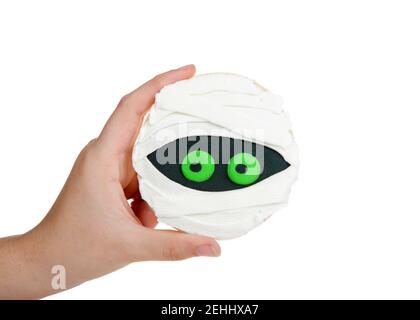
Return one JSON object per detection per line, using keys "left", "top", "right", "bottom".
{"left": 138, "top": 228, "right": 221, "bottom": 261}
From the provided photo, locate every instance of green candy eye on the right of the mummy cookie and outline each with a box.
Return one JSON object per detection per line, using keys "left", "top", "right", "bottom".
{"left": 227, "top": 153, "right": 261, "bottom": 186}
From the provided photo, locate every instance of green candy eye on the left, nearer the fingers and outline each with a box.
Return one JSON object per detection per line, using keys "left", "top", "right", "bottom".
{"left": 181, "top": 149, "right": 215, "bottom": 182}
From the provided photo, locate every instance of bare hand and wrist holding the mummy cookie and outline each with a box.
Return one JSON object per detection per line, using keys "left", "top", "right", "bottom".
{"left": 0, "top": 65, "right": 220, "bottom": 299}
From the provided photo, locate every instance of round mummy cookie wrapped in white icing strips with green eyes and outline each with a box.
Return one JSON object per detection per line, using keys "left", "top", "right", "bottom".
{"left": 133, "top": 73, "right": 299, "bottom": 239}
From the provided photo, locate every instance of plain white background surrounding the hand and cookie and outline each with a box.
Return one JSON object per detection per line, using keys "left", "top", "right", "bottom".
{"left": 0, "top": 0, "right": 420, "bottom": 299}
